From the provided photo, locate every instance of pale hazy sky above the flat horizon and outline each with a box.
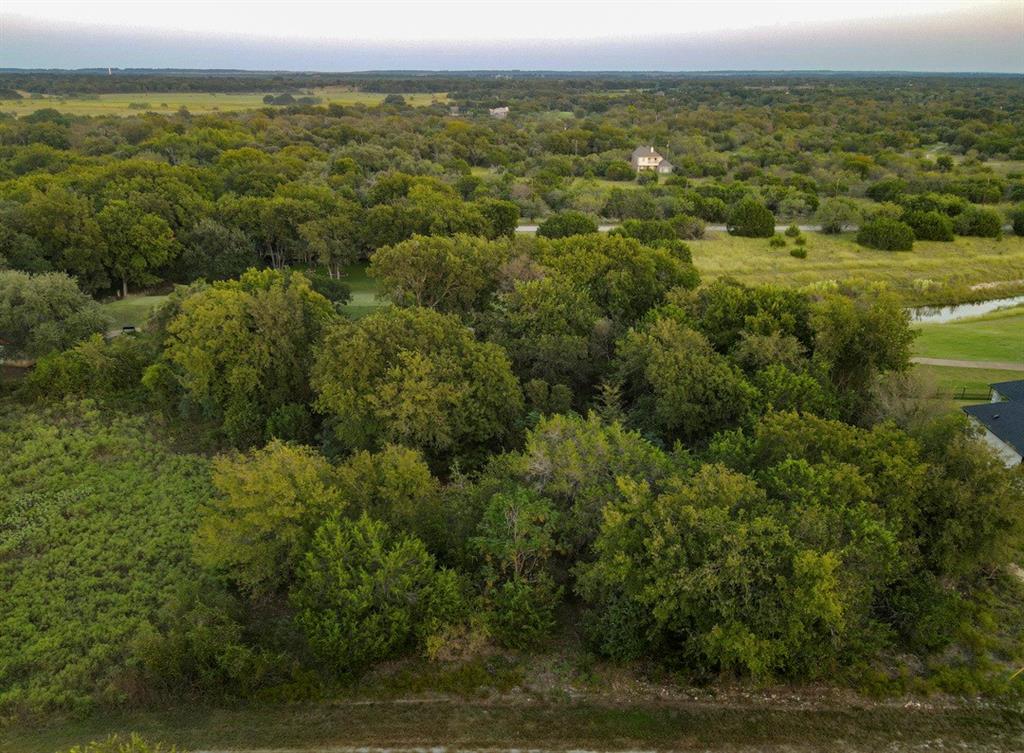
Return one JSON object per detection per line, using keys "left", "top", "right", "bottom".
{"left": 0, "top": 0, "right": 1024, "bottom": 73}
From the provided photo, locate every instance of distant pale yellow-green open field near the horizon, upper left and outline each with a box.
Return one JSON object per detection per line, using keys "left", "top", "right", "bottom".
{"left": 0, "top": 87, "right": 447, "bottom": 115}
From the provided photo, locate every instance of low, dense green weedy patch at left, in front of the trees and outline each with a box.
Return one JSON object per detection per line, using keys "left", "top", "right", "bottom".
{"left": 0, "top": 402, "right": 210, "bottom": 712}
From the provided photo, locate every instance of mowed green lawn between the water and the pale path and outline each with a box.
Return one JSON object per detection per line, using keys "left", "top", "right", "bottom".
{"left": 914, "top": 306, "right": 1024, "bottom": 364}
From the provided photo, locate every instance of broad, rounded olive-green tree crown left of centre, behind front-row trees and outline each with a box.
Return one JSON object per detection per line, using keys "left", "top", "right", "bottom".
{"left": 311, "top": 307, "right": 522, "bottom": 467}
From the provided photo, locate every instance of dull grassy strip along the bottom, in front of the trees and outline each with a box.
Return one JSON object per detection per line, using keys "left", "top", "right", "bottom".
{"left": 6, "top": 698, "right": 1024, "bottom": 753}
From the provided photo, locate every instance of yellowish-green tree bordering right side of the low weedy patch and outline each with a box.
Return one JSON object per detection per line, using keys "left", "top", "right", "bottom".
{"left": 195, "top": 440, "right": 345, "bottom": 594}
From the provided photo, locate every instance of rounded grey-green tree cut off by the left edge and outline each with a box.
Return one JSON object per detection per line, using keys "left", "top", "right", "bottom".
{"left": 0, "top": 269, "right": 110, "bottom": 359}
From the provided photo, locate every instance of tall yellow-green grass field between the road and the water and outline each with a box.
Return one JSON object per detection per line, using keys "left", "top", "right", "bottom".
{"left": 688, "top": 233, "right": 1024, "bottom": 304}
